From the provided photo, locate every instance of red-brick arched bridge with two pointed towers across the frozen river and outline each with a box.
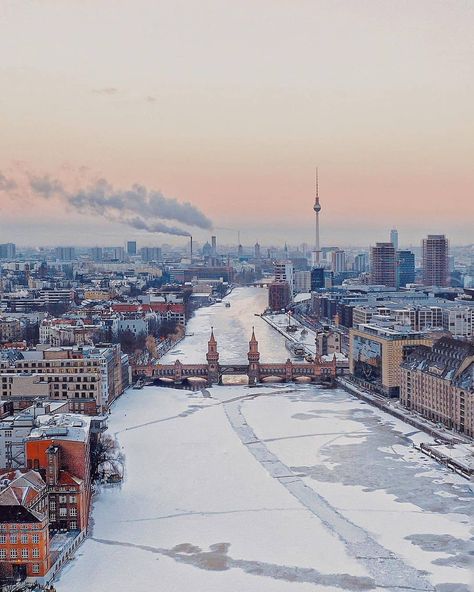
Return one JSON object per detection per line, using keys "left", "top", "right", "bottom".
{"left": 135, "top": 328, "right": 336, "bottom": 386}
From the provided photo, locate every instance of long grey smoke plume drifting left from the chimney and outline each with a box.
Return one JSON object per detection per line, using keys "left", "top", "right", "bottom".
{"left": 25, "top": 175, "right": 212, "bottom": 236}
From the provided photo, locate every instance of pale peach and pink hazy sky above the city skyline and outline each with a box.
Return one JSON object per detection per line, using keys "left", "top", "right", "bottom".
{"left": 0, "top": 0, "right": 474, "bottom": 246}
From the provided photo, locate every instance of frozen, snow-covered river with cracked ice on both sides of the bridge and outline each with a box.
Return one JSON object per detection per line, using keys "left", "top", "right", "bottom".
{"left": 56, "top": 288, "right": 473, "bottom": 592}
